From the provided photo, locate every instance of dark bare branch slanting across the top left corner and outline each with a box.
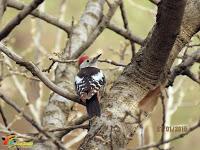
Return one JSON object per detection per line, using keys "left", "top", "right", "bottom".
{"left": 0, "top": 0, "right": 44, "bottom": 41}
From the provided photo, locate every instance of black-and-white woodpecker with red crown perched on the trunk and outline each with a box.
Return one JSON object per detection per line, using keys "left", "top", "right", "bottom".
{"left": 75, "top": 54, "right": 106, "bottom": 118}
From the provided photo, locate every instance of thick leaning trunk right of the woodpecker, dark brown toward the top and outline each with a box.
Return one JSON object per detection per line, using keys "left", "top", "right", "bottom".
{"left": 80, "top": 0, "right": 186, "bottom": 150}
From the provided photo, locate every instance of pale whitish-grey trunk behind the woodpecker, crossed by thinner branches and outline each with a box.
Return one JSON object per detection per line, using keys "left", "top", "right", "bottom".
{"left": 34, "top": 0, "right": 104, "bottom": 149}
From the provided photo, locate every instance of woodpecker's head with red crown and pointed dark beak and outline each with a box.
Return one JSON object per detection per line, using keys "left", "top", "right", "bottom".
{"left": 78, "top": 54, "right": 101, "bottom": 68}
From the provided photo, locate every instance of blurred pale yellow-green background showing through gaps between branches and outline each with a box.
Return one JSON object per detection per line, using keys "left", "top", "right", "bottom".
{"left": 0, "top": 0, "right": 200, "bottom": 150}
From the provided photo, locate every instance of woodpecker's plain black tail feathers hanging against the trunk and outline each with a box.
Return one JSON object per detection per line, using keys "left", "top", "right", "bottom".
{"left": 86, "top": 94, "right": 101, "bottom": 118}
